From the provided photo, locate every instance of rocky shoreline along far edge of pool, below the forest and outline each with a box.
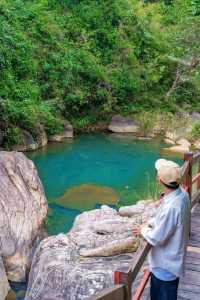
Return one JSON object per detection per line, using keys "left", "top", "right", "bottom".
{"left": 0, "top": 112, "right": 200, "bottom": 155}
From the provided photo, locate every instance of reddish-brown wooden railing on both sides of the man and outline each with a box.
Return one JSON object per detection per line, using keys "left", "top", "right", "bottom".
{"left": 89, "top": 152, "right": 200, "bottom": 300}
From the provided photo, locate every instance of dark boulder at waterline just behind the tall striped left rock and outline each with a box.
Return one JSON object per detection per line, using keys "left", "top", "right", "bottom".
{"left": 12, "top": 130, "right": 38, "bottom": 152}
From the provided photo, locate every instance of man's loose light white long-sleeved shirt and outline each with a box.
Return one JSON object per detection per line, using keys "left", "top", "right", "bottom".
{"left": 141, "top": 188, "right": 190, "bottom": 277}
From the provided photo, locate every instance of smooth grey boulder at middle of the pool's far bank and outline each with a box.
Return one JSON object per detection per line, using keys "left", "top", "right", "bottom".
{"left": 108, "top": 115, "right": 139, "bottom": 133}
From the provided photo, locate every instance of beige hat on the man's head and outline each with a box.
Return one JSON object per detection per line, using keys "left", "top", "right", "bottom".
{"left": 155, "top": 158, "right": 181, "bottom": 185}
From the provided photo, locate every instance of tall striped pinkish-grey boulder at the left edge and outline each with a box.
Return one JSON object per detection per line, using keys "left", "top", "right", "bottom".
{"left": 0, "top": 152, "right": 47, "bottom": 282}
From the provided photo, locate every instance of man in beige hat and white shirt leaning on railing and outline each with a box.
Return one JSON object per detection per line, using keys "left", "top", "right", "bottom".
{"left": 133, "top": 159, "right": 190, "bottom": 300}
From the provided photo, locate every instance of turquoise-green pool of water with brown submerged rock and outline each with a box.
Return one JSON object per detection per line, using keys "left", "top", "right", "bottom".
{"left": 28, "top": 134, "right": 181, "bottom": 234}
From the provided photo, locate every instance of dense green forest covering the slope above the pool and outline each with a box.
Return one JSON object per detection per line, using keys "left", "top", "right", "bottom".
{"left": 0, "top": 0, "right": 200, "bottom": 144}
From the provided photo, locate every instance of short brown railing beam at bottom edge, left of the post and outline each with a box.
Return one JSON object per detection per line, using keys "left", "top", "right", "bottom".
{"left": 88, "top": 284, "right": 126, "bottom": 300}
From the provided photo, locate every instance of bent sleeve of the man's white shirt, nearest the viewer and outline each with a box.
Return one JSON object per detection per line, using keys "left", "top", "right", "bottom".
{"left": 141, "top": 208, "right": 177, "bottom": 246}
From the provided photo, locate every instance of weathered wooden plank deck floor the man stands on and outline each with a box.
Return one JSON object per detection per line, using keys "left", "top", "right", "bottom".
{"left": 133, "top": 204, "right": 200, "bottom": 300}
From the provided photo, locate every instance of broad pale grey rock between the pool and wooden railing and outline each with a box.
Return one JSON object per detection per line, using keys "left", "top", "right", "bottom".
{"left": 25, "top": 201, "right": 157, "bottom": 300}
